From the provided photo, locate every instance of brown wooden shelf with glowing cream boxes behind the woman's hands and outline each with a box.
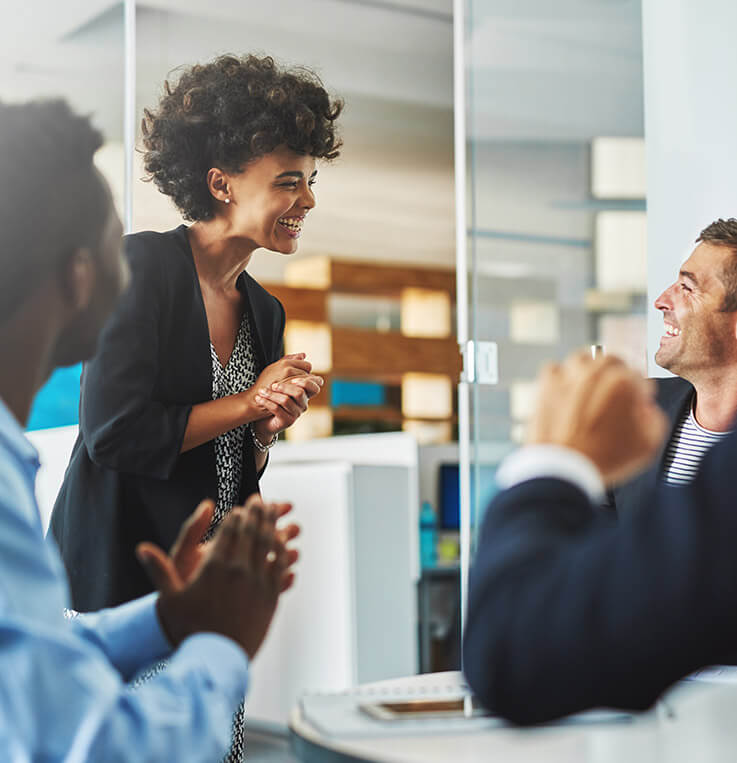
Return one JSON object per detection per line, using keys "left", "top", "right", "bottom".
{"left": 264, "top": 257, "right": 462, "bottom": 442}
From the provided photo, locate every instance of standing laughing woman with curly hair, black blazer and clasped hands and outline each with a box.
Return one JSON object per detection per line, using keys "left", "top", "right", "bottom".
{"left": 51, "top": 56, "right": 342, "bottom": 760}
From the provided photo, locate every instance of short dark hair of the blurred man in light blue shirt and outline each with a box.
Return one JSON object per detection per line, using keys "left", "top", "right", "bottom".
{"left": 0, "top": 99, "right": 109, "bottom": 324}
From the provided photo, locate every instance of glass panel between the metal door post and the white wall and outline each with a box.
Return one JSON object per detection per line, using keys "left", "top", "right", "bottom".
{"left": 456, "top": 0, "right": 646, "bottom": 620}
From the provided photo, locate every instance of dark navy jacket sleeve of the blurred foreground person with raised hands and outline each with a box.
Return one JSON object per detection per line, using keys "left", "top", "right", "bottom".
{"left": 464, "top": 432, "right": 737, "bottom": 723}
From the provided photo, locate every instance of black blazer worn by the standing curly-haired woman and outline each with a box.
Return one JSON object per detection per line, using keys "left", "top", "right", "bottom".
{"left": 51, "top": 225, "right": 284, "bottom": 611}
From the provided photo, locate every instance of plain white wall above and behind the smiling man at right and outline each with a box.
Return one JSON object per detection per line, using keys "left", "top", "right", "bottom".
{"left": 643, "top": 0, "right": 737, "bottom": 376}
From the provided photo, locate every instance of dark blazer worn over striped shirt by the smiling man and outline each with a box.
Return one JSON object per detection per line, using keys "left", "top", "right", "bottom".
{"left": 605, "top": 376, "right": 694, "bottom": 517}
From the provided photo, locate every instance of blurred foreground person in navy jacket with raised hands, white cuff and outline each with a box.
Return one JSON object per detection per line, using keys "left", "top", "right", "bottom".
{"left": 464, "top": 350, "right": 737, "bottom": 723}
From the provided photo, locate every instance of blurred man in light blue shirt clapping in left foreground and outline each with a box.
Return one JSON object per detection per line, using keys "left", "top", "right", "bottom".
{"left": 0, "top": 101, "right": 297, "bottom": 763}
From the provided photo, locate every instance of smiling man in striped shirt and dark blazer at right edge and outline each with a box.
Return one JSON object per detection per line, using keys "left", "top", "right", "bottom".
{"left": 607, "top": 218, "right": 737, "bottom": 516}
